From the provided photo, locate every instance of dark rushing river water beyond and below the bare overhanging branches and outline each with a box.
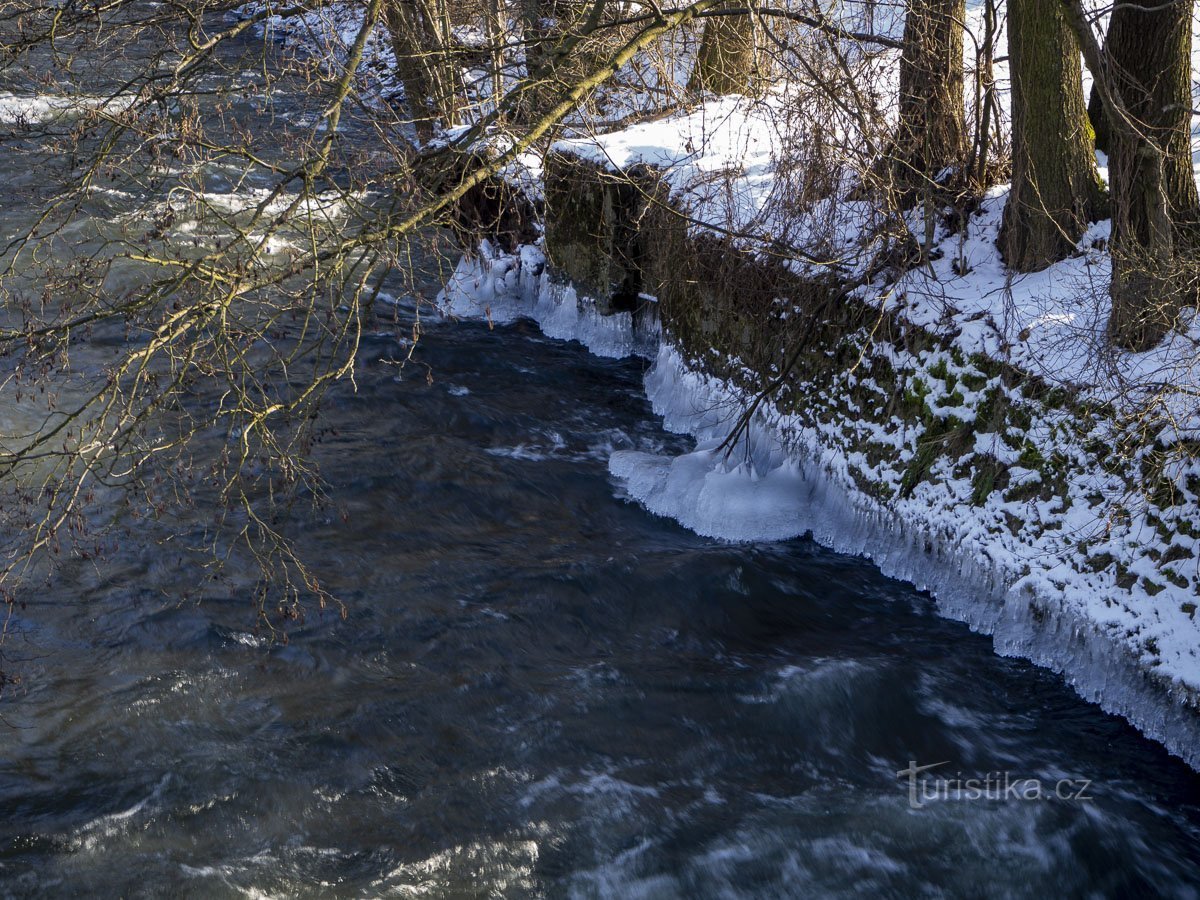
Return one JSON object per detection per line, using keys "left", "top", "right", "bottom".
{"left": 0, "top": 8, "right": 1200, "bottom": 898}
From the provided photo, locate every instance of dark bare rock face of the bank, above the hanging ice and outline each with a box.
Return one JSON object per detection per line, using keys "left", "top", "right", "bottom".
{"left": 545, "top": 145, "right": 916, "bottom": 415}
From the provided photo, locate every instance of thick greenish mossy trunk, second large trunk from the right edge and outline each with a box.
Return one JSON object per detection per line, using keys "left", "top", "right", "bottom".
{"left": 1000, "top": 0, "right": 1100, "bottom": 272}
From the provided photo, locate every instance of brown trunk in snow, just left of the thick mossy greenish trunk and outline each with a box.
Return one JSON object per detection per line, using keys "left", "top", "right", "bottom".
{"left": 889, "top": 0, "right": 967, "bottom": 197}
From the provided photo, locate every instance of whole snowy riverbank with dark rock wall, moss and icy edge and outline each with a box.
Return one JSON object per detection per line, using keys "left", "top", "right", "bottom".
{"left": 444, "top": 91, "right": 1200, "bottom": 767}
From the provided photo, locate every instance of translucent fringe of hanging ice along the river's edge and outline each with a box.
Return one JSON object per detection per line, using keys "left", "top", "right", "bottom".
{"left": 439, "top": 246, "right": 1200, "bottom": 769}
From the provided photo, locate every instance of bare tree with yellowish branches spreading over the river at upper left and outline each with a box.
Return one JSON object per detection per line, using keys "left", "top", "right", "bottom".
{"left": 0, "top": 0, "right": 739, "bottom": 631}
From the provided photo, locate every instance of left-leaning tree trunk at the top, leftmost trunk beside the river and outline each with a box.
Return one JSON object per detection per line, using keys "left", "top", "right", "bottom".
{"left": 384, "top": 0, "right": 463, "bottom": 142}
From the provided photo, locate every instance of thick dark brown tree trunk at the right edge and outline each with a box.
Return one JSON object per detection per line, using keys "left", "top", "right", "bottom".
{"left": 1104, "top": 0, "right": 1200, "bottom": 349}
